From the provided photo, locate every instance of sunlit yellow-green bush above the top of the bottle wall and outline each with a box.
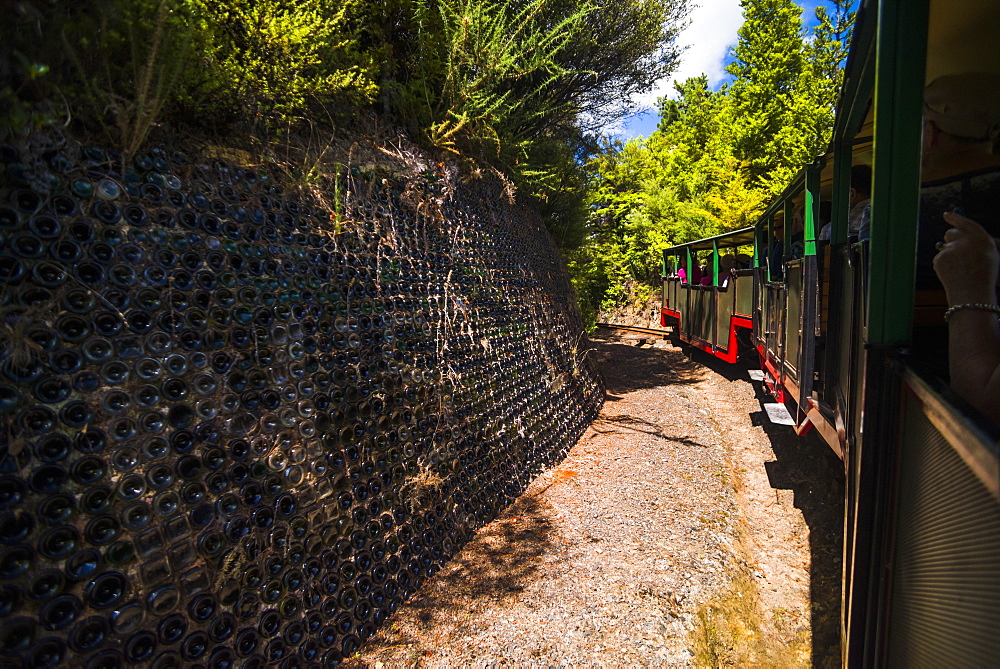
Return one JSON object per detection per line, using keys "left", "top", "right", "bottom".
{"left": 186, "top": 0, "right": 377, "bottom": 132}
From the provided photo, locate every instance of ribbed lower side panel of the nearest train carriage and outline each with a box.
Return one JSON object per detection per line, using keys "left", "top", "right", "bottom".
{"left": 888, "top": 388, "right": 1000, "bottom": 667}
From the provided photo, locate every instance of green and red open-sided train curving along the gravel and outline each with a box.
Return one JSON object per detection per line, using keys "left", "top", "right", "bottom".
{"left": 661, "top": 0, "right": 1000, "bottom": 666}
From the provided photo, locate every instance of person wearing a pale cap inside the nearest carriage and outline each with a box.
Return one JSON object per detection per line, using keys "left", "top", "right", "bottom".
{"left": 917, "top": 72, "right": 1000, "bottom": 288}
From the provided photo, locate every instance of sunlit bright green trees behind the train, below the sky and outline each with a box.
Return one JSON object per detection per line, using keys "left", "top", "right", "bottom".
{"left": 570, "top": 0, "right": 854, "bottom": 324}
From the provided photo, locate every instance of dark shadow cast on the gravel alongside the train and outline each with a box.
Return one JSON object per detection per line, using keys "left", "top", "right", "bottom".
{"left": 691, "top": 351, "right": 844, "bottom": 667}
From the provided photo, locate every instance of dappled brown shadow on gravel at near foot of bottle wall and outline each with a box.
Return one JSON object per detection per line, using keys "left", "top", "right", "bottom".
{"left": 344, "top": 494, "right": 558, "bottom": 667}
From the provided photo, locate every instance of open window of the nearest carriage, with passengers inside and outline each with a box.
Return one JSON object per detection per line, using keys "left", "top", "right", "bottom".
{"left": 914, "top": 2, "right": 1000, "bottom": 420}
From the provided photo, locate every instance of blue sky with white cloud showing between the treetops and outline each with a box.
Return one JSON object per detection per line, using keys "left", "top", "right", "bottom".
{"left": 608, "top": 0, "right": 832, "bottom": 140}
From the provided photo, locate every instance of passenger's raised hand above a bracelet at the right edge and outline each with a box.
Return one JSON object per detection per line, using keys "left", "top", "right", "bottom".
{"left": 934, "top": 211, "right": 1000, "bottom": 305}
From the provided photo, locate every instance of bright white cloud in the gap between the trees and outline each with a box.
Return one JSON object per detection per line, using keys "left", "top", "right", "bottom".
{"left": 634, "top": 0, "right": 743, "bottom": 109}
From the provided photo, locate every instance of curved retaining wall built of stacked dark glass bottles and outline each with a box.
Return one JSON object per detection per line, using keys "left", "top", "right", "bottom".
{"left": 0, "top": 146, "right": 603, "bottom": 667}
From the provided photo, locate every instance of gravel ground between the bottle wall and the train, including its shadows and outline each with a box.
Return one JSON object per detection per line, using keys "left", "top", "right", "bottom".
{"left": 346, "top": 332, "right": 842, "bottom": 668}
